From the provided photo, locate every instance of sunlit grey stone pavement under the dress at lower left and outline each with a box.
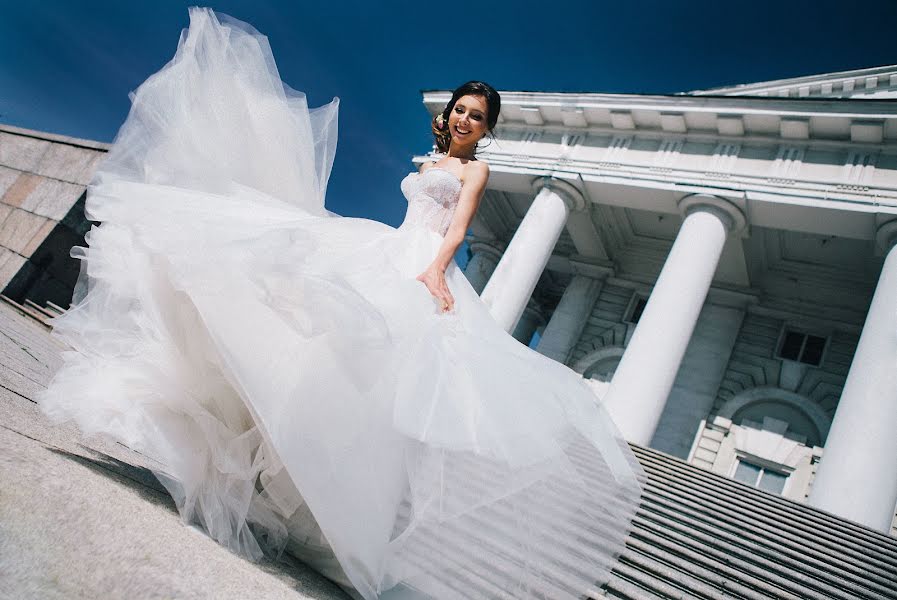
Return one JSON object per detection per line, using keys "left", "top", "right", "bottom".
{"left": 0, "top": 302, "right": 348, "bottom": 600}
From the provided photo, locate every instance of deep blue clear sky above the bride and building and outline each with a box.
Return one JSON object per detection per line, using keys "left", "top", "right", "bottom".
{"left": 0, "top": 0, "right": 897, "bottom": 232}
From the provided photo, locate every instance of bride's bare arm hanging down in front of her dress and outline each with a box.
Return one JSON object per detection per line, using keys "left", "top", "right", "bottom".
{"left": 417, "top": 161, "right": 489, "bottom": 312}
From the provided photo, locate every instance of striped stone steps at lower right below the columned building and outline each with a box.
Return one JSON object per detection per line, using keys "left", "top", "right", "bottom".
{"left": 591, "top": 446, "right": 897, "bottom": 600}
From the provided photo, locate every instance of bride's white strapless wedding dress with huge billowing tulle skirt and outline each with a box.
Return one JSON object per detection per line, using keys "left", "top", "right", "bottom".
{"left": 39, "top": 9, "right": 642, "bottom": 600}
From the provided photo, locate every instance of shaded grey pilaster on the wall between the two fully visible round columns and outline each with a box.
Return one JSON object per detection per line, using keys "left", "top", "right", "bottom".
{"left": 536, "top": 275, "right": 604, "bottom": 364}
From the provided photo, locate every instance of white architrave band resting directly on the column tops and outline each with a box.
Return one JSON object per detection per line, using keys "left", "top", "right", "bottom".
{"left": 416, "top": 152, "right": 897, "bottom": 245}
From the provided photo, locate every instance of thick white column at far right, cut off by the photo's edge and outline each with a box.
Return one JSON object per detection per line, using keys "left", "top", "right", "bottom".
{"left": 808, "top": 221, "right": 897, "bottom": 533}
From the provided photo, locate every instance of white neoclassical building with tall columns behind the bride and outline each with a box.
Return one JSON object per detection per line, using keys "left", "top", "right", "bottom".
{"left": 415, "top": 66, "right": 897, "bottom": 532}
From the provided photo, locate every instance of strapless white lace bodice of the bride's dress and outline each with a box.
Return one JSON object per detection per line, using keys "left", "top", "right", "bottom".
{"left": 399, "top": 167, "right": 461, "bottom": 236}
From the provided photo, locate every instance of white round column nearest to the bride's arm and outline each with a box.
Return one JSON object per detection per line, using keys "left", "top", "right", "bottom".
{"left": 480, "top": 177, "right": 585, "bottom": 333}
